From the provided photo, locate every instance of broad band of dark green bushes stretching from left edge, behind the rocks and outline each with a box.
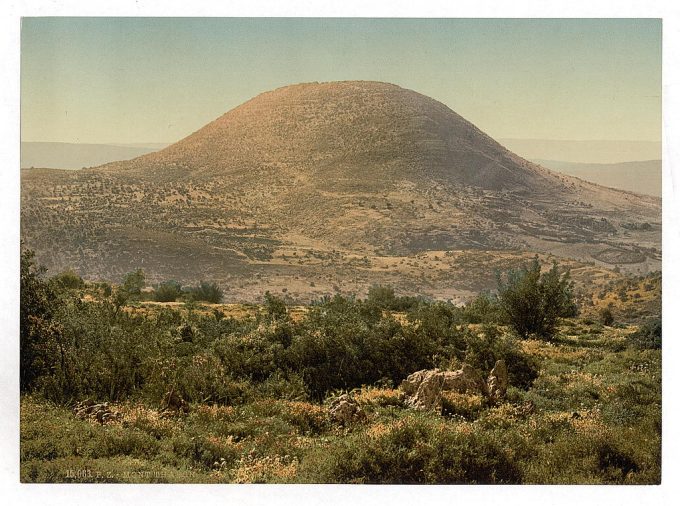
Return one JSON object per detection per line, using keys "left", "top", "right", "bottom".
{"left": 22, "top": 253, "right": 556, "bottom": 404}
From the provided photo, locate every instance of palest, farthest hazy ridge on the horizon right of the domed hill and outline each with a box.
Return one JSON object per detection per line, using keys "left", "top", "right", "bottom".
{"left": 498, "top": 139, "right": 661, "bottom": 163}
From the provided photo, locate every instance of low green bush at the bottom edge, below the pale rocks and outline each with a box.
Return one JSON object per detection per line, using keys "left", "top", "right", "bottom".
{"left": 302, "top": 415, "right": 521, "bottom": 484}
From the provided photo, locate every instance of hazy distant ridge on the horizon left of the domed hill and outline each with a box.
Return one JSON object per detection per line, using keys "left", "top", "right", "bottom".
{"left": 21, "top": 142, "right": 164, "bottom": 169}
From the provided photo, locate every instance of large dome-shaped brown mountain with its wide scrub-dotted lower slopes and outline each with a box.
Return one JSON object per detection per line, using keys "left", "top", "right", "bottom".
{"left": 22, "top": 81, "right": 661, "bottom": 299}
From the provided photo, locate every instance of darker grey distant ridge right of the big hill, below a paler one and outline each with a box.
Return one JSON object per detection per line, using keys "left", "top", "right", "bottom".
{"left": 532, "top": 159, "right": 661, "bottom": 197}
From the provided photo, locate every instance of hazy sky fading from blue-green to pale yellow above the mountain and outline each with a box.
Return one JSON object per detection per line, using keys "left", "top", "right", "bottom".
{"left": 21, "top": 18, "right": 661, "bottom": 143}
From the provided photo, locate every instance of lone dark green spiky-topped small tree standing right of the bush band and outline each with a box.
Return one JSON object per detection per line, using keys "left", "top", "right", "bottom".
{"left": 498, "top": 257, "right": 575, "bottom": 339}
